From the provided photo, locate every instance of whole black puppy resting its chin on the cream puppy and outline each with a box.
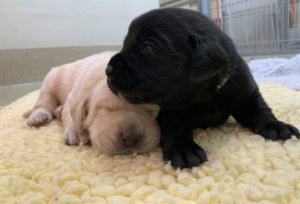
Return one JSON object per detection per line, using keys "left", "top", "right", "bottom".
{"left": 106, "top": 8, "right": 300, "bottom": 168}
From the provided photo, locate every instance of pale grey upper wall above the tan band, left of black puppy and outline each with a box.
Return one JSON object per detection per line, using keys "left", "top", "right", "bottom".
{"left": 0, "top": 0, "right": 159, "bottom": 49}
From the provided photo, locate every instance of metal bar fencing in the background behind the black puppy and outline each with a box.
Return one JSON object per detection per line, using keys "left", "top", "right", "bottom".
{"left": 160, "top": 0, "right": 300, "bottom": 55}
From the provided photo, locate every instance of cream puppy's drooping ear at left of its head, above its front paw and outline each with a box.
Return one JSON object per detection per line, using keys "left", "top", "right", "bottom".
{"left": 72, "top": 98, "right": 89, "bottom": 133}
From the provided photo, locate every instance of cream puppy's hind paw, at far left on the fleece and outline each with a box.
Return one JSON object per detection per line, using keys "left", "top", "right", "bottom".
{"left": 27, "top": 108, "right": 53, "bottom": 126}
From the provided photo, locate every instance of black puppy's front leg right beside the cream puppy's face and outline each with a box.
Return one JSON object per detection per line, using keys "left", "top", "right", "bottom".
{"left": 158, "top": 110, "right": 207, "bottom": 168}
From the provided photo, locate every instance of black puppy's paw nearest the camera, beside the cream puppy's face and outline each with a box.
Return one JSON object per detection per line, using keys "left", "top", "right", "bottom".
{"left": 163, "top": 142, "right": 208, "bottom": 169}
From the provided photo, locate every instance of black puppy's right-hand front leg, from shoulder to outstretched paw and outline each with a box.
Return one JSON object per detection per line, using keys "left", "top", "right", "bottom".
{"left": 227, "top": 58, "right": 300, "bottom": 140}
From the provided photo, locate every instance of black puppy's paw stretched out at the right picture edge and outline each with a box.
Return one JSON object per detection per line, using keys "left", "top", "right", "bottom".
{"left": 255, "top": 121, "right": 300, "bottom": 140}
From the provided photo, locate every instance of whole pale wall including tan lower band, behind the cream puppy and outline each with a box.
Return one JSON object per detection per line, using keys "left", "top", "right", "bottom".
{"left": 0, "top": 0, "right": 159, "bottom": 106}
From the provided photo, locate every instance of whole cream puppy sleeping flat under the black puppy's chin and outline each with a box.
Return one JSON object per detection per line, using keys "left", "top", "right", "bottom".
{"left": 24, "top": 52, "right": 160, "bottom": 154}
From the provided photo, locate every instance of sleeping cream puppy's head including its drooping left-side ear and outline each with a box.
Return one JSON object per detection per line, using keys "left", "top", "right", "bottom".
{"left": 74, "top": 96, "right": 160, "bottom": 154}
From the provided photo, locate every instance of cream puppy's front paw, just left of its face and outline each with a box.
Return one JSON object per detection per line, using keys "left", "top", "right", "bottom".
{"left": 64, "top": 125, "right": 90, "bottom": 145}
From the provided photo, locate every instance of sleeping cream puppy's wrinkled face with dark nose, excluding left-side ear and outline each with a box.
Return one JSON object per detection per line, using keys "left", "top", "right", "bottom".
{"left": 89, "top": 105, "right": 160, "bottom": 154}
